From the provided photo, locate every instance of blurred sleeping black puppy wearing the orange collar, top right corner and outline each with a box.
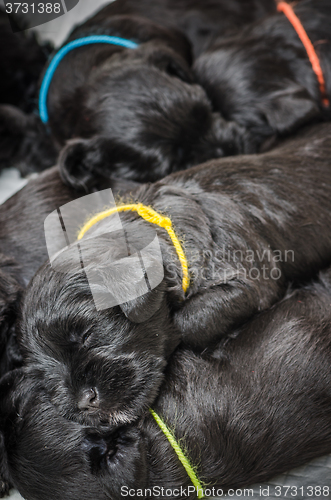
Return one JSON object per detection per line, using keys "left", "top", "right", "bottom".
{"left": 194, "top": 0, "right": 331, "bottom": 146}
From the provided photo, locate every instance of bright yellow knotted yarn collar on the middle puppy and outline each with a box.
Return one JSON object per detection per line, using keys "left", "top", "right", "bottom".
{"left": 77, "top": 203, "right": 190, "bottom": 292}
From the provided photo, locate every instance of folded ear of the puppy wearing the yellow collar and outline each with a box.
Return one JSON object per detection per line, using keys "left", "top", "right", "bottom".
{"left": 120, "top": 286, "right": 165, "bottom": 323}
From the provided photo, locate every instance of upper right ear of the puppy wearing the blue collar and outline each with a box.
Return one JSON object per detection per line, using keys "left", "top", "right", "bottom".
{"left": 148, "top": 49, "right": 194, "bottom": 83}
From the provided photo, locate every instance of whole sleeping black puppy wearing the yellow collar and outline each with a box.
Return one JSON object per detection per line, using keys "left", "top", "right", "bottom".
{"left": 20, "top": 124, "right": 331, "bottom": 426}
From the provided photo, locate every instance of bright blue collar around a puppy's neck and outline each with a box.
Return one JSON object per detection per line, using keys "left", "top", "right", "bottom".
{"left": 39, "top": 35, "right": 139, "bottom": 123}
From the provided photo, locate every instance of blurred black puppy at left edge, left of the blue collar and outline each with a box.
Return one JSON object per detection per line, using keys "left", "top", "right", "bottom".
{"left": 0, "top": 9, "right": 58, "bottom": 175}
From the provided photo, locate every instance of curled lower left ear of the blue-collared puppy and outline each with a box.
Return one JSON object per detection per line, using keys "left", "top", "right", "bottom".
{"left": 59, "top": 136, "right": 145, "bottom": 192}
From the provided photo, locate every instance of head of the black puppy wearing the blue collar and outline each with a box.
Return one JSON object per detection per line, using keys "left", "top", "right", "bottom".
{"left": 49, "top": 38, "right": 249, "bottom": 187}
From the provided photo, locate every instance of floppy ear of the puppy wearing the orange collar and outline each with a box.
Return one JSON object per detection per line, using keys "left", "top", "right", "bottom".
{"left": 262, "top": 85, "right": 320, "bottom": 134}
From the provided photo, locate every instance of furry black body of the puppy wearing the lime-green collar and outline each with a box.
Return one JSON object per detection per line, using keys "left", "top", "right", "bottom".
{"left": 148, "top": 269, "right": 331, "bottom": 492}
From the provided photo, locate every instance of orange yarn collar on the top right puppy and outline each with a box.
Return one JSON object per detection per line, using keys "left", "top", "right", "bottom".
{"left": 277, "top": 2, "right": 330, "bottom": 107}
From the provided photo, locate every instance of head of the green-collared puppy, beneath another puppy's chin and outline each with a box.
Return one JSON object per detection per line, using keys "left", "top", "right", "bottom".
{"left": 0, "top": 370, "right": 147, "bottom": 500}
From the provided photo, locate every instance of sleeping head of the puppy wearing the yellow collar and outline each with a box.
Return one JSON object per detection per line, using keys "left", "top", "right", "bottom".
{"left": 20, "top": 227, "right": 179, "bottom": 426}
